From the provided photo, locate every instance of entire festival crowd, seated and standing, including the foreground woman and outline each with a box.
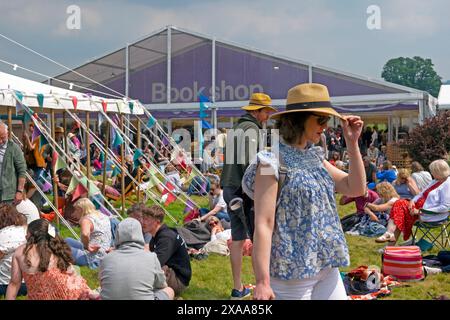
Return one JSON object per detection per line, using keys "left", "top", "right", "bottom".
{"left": 0, "top": 83, "right": 450, "bottom": 300}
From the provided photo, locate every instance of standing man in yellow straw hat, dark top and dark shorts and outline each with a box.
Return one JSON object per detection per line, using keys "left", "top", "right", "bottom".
{"left": 221, "top": 93, "right": 276, "bottom": 299}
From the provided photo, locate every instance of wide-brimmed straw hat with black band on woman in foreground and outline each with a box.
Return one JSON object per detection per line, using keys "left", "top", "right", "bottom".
{"left": 270, "top": 83, "right": 343, "bottom": 119}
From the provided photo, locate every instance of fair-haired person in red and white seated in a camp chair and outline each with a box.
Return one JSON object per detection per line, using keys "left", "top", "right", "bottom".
{"left": 376, "top": 160, "right": 450, "bottom": 245}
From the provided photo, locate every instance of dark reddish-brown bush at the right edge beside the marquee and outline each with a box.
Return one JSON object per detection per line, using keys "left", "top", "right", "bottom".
{"left": 404, "top": 111, "right": 450, "bottom": 167}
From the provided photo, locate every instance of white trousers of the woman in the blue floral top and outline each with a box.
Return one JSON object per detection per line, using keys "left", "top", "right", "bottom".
{"left": 270, "top": 268, "right": 348, "bottom": 300}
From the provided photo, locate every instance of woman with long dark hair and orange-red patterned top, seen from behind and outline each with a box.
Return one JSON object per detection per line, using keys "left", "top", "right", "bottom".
{"left": 6, "top": 219, "right": 98, "bottom": 300}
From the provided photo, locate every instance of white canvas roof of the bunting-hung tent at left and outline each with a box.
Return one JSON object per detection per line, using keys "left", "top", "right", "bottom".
{"left": 0, "top": 72, "right": 144, "bottom": 115}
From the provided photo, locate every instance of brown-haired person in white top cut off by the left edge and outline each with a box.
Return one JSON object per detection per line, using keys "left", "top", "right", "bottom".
{"left": 0, "top": 203, "right": 27, "bottom": 296}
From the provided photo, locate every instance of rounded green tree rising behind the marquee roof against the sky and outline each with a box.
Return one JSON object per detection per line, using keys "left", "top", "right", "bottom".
{"left": 381, "top": 57, "right": 442, "bottom": 97}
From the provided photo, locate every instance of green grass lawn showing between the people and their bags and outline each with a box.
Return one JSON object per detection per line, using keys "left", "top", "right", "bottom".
{"left": 19, "top": 198, "right": 450, "bottom": 300}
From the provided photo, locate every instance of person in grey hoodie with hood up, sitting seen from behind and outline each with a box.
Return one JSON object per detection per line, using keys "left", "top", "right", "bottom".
{"left": 99, "top": 218, "right": 174, "bottom": 300}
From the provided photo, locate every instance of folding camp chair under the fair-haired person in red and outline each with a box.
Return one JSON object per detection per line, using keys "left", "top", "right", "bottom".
{"left": 412, "top": 209, "right": 450, "bottom": 251}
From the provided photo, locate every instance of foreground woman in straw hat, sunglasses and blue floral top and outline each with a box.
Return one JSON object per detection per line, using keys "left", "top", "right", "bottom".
{"left": 242, "top": 83, "right": 366, "bottom": 300}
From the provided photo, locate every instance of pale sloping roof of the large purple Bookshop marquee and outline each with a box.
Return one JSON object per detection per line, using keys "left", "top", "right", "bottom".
{"left": 51, "top": 26, "right": 423, "bottom": 99}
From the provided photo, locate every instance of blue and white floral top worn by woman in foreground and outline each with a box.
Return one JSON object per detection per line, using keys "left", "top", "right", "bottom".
{"left": 242, "top": 143, "right": 350, "bottom": 280}
